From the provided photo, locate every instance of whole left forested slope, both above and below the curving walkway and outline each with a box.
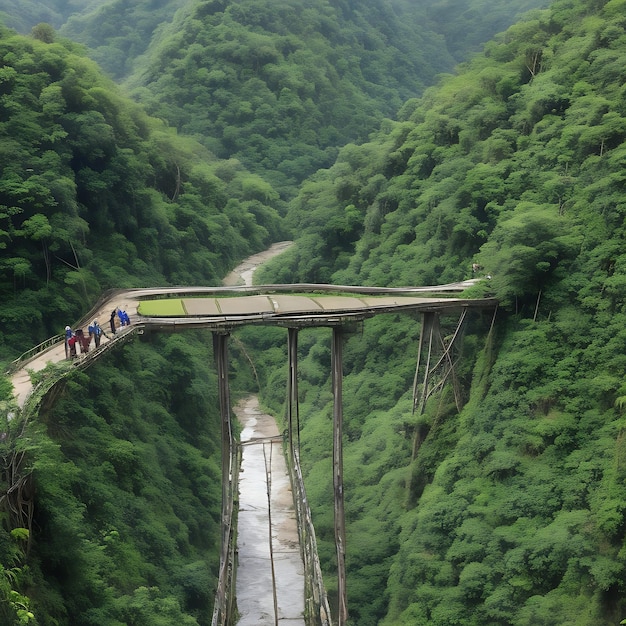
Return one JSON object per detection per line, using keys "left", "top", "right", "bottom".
{"left": 0, "top": 27, "right": 272, "bottom": 626}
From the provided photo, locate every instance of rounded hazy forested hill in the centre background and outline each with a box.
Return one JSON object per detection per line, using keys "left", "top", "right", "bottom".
{"left": 122, "top": 0, "right": 452, "bottom": 193}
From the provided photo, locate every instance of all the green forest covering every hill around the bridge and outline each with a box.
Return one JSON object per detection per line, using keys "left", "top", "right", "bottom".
{"left": 0, "top": 0, "right": 626, "bottom": 626}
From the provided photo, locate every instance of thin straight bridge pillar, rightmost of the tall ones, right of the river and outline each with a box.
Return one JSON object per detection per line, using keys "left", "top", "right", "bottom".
{"left": 331, "top": 326, "right": 348, "bottom": 626}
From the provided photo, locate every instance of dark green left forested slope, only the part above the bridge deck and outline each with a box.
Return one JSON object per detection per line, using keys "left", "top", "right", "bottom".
{"left": 0, "top": 22, "right": 281, "bottom": 354}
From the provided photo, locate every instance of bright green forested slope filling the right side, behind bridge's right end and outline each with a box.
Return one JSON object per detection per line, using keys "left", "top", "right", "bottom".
{"left": 251, "top": 0, "right": 626, "bottom": 626}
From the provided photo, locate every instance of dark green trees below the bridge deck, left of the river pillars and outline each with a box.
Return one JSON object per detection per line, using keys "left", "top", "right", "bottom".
{"left": 29, "top": 335, "right": 221, "bottom": 626}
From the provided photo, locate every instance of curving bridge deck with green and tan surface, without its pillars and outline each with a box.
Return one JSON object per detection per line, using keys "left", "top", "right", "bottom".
{"left": 8, "top": 280, "right": 495, "bottom": 406}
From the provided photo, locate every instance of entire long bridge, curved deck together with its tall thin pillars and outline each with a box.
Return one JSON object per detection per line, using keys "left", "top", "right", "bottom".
{"left": 8, "top": 280, "right": 497, "bottom": 626}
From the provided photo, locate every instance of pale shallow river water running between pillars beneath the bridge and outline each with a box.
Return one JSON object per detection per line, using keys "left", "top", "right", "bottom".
{"left": 235, "top": 396, "right": 305, "bottom": 626}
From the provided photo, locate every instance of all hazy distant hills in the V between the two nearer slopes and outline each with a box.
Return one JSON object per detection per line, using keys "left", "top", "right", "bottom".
{"left": 0, "top": 0, "right": 545, "bottom": 199}
